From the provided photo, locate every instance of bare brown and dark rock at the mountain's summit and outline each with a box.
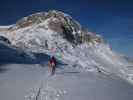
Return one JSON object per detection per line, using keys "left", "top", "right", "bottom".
{"left": 6, "top": 10, "right": 103, "bottom": 48}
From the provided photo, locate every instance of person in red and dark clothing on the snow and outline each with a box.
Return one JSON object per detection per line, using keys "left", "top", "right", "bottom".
{"left": 48, "top": 56, "right": 56, "bottom": 75}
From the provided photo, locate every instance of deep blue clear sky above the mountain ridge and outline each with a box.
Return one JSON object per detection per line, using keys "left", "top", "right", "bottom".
{"left": 0, "top": 0, "right": 133, "bottom": 57}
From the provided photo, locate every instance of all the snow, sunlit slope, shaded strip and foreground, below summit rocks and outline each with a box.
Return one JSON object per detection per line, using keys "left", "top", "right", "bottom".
{"left": 0, "top": 10, "right": 133, "bottom": 100}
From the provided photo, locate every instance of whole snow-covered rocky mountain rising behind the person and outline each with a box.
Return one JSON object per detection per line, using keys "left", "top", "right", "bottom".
{"left": 0, "top": 10, "right": 133, "bottom": 83}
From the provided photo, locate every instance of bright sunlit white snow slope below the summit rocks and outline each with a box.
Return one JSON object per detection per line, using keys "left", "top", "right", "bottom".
{"left": 1, "top": 18, "right": 133, "bottom": 83}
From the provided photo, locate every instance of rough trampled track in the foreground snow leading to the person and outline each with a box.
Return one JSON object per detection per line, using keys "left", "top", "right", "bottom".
{"left": 25, "top": 65, "right": 66, "bottom": 100}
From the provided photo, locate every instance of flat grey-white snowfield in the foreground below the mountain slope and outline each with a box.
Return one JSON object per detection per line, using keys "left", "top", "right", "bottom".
{"left": 0, "top": 64, "right": 133, "bottom": 100}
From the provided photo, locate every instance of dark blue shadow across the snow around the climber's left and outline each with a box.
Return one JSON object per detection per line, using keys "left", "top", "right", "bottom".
{"left": 0, "top": 43, "right": 67, "bottom": 73}
